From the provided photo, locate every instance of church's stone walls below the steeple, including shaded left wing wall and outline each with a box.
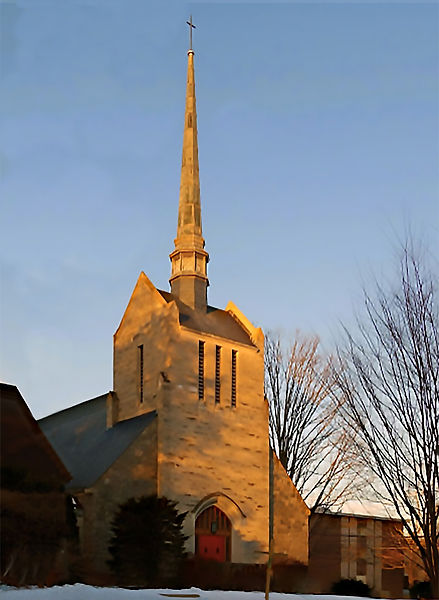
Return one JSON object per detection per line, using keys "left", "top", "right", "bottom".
{"left": 67, "top": 266, "right": 309, "bottom": 573}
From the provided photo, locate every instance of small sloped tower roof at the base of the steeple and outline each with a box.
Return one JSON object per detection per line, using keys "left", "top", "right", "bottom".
{"left": 158, "top": 290, "right": 254, "bottom": 346}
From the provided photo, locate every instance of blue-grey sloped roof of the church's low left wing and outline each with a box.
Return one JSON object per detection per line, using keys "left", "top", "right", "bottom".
{"left": 39, "top": 394, "right": 156, "bottom": 489}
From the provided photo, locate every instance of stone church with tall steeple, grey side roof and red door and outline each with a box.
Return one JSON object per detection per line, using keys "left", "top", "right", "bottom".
{"left": 39, "top": 38, "right": 309, "bottom": 573}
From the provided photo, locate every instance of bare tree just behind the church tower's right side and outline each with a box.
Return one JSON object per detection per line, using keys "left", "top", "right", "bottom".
{"left": 265, "top": 334, "right": 354, "bottom": 512}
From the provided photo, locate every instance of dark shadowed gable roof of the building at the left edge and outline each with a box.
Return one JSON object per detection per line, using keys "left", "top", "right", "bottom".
{"left": 0, "top": 383, "right": 71, "bottom": 485}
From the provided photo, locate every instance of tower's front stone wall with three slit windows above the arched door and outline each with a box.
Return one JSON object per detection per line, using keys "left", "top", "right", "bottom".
{"left": 158, "top": 327, "right": 269, "bottom": 563}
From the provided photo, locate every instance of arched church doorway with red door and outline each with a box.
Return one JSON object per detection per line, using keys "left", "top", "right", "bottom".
{"left": 195, "top": 506, "right": 232, "bottom": 562}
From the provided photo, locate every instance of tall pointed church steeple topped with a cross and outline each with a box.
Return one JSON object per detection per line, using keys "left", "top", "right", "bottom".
{"left": 169, "top": 24, "right": 209, "bottom": 310}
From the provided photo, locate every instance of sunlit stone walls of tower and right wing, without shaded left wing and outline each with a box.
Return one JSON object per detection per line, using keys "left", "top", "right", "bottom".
{"left": 110, "top": 274, "right": 308, "bottom": 563}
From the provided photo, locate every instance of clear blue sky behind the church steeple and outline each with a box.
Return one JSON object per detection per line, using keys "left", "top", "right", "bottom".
{"left": 0, "top": 0, "right": 439, "bottom": 417}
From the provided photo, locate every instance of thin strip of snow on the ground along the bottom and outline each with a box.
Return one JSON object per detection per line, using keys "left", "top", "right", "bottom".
{"left": 0, "top": 583, "right": 402, "bottom": 600}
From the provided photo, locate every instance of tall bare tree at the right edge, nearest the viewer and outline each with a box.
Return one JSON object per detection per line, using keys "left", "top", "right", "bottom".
{"left": 337, "top": 244, "right": 439, "bottom": 598}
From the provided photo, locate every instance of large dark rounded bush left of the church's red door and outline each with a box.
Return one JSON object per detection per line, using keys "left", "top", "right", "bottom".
{"left": 108, "top": 496, "right": 187, "bottom": 587}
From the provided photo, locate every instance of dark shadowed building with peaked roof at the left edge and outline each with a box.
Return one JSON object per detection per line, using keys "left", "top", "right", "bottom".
{"left": 0, "top": 383, "right": 74, "bottom": 586}
